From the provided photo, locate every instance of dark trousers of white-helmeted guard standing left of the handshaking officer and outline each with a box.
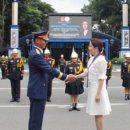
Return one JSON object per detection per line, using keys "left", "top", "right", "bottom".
{"left": 10, "top": 79, "right": 20, "bottom": 100}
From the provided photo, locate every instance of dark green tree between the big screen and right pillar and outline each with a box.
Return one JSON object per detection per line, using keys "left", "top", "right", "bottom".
{"left": 82, "top": 0, "right": 130, "bottom": 37}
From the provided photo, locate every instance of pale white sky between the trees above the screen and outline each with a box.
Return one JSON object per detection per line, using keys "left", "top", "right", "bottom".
{"left": 41, "top": 0, "right": 88, "bottom": 13}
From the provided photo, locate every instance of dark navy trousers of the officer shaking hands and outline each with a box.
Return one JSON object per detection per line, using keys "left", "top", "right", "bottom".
{"left": 28, "top": 98, "right": 46, "bottom": 130}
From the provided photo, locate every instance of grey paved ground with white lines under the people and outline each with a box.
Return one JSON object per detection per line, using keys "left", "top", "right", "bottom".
{"left": 0, "top": 66, "right": 130, "bottom": 130}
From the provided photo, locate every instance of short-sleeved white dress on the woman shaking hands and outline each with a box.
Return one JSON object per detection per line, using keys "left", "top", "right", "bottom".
{"left": 85, "top": 55, "right": 111, "bottom": 115}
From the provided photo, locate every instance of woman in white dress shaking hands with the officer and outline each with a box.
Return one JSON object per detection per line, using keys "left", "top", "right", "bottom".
{"left": 76, "top": 38, "right": 111, "bottom": 130}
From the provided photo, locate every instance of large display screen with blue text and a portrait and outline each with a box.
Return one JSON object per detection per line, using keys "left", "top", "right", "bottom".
{"left": 49, "top": 14, "right": 92, "bottom": 39}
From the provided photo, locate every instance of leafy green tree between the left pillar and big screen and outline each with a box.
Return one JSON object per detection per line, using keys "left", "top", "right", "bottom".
{"left": 19, "top": 0, "right": 54, "bottom": 36}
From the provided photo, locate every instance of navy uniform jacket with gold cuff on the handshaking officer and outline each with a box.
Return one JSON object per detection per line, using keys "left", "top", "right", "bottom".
{"left": 27, "top": 47, "right": 67, "bottom": 99}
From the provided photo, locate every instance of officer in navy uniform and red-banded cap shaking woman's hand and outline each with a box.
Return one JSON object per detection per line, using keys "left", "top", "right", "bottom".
{"left": 27, "top": 32, "right": 76, "bottom": 130}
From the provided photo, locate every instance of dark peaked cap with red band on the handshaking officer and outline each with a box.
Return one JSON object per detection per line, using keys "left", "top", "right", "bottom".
{"left": 34, "top": 31, "right": 49, "bottom": 41}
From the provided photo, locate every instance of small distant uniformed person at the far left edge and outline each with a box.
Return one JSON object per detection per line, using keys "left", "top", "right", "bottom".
{"left": 1, "top": 55, "right": 7, "bottom": 79}
